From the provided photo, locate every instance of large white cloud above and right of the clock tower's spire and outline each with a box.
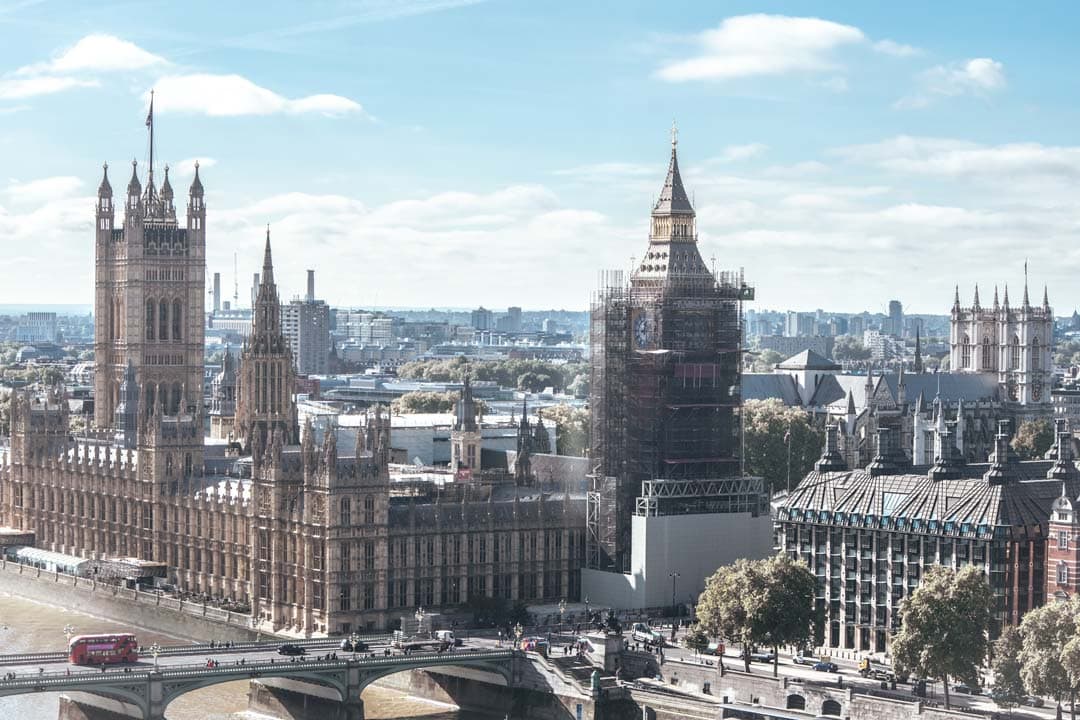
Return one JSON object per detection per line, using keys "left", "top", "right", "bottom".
{"left": 658, "top": 14, "right": 866, "bottom": 82}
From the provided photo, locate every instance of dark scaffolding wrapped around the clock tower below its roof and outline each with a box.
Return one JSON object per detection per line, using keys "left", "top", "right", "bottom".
{"left": 586, "top": 259, "right": 757, "bottom": 572}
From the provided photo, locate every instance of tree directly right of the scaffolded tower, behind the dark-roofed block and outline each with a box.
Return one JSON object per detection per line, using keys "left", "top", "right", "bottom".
{"left": 742, "top": 398, "right": 825, "bottom": 494}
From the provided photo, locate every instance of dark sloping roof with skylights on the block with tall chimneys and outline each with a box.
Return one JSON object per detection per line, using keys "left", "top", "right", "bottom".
{"left": 778, "top": 461, "right": 1080, "bottom": 538}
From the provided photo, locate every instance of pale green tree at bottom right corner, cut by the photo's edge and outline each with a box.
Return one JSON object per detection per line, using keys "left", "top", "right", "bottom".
{"left": 1020, "top": 598, "right": 1080, "bottom": 706}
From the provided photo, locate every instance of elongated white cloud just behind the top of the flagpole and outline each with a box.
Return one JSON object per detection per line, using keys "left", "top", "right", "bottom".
{"left": 147, "top": 73, "right": 364, "bottom": 117}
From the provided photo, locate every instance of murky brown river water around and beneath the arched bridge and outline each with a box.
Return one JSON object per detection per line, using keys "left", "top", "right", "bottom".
{"left": 0, "top": 594, "right": 495, "bottom": 720}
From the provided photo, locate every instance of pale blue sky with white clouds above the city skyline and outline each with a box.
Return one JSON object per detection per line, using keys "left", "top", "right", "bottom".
{"left": 0, "top": 0, "right": 1080, "bottom": 315}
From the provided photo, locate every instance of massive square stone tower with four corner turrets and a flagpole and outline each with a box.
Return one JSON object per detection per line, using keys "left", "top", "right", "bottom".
{"left": 94, "top": 99, "right": 206, "bottom": 427}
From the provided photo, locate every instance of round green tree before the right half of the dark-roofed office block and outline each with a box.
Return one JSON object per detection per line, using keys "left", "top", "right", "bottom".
{"left": 892, "top": 566, "right": 994, "bottom": 709}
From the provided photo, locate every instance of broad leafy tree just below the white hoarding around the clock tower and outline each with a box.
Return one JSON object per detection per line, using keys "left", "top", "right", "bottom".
{"left": 697, "top": 554, "right": 815, "bottom": 675}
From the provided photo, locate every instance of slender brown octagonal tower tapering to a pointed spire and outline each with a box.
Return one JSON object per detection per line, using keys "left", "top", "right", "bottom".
{"left": 233, "top": 227, "right": 299, "bottom": 452}
